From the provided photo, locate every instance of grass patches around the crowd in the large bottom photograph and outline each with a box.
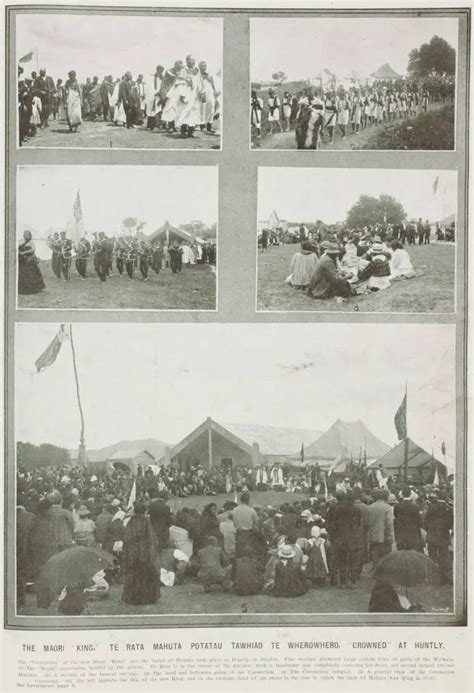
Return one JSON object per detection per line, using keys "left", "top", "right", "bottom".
{"left": 18, "top": 491, "right": 453, "bottom": 625}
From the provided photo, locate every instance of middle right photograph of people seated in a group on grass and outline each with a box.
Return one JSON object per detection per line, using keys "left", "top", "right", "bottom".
{"left": 257, "top": 167, "right": 457, "bottom": 313}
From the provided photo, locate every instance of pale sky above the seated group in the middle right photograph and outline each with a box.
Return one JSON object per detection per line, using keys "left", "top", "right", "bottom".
{"left": 258, "top": 167, "right": 457, "bottom": 224}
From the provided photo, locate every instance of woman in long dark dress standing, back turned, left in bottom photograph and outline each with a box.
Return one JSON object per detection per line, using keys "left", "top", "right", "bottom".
{"left": 122, "top": 502, "right": 160, "bottom": 604}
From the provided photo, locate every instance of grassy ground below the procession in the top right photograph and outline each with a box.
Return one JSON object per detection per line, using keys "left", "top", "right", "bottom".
{"left": 252, "top": 104, "right": 454, "bottom": 151}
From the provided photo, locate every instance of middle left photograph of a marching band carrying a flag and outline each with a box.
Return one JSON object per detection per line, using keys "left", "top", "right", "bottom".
{"left": 16, "top": 166, "right": 218, "bottom": 310}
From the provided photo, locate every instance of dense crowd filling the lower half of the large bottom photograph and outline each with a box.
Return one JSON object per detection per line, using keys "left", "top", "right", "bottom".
{"left": 17, "top": 465, "right": 453, "bottom": 613}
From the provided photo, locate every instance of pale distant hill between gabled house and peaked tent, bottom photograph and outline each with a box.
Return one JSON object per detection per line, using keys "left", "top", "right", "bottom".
{"left": 222, "top": 423, "right": 321, "bottom": 456}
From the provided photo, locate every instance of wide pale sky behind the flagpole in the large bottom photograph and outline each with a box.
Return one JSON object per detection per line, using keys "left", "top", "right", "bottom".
{"left": 15, "top": 323, "right": 456, "bottom": 455}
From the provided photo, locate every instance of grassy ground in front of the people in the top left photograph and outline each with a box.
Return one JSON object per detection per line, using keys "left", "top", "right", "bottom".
{"left": 23, "top": 120, "right": 221, "bottom": 149}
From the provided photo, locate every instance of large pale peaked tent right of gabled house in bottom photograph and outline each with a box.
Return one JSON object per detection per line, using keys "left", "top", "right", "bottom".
{"left": 305, "top": 419, "right": 390, "bottom": 460}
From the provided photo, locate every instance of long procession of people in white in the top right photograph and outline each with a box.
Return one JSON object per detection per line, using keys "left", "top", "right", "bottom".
{"left": 250, "top": 78, "right": 454, "bottom": 149}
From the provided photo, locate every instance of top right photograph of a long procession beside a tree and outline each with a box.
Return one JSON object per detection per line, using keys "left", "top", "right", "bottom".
{"left": 250, "top": 16, "right": 458, "bottom": 151}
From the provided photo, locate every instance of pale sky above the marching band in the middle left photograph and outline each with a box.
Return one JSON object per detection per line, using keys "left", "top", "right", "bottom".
{"left": 17, "top": 166, "right": 218, "bottom": 257}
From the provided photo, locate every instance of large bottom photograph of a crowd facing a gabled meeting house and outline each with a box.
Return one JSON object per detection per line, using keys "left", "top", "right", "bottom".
{"left": 12, "top": 323, "right": 462, "bottom": 626}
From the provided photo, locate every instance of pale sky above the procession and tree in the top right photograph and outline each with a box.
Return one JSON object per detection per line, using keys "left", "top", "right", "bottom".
{"left": 250, "top": 17, "right": 458, "bottom": 82}
